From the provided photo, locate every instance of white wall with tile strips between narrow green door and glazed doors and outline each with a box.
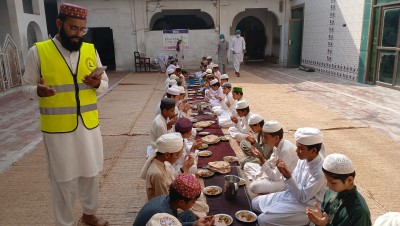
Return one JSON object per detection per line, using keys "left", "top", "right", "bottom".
{"left": 292, "top": 0, "right": 364, "bottom": 80}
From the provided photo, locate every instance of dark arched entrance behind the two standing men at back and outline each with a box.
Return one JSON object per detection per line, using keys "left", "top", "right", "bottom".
{"left": 236, "top": 16, "right": 267, "bottom": 60}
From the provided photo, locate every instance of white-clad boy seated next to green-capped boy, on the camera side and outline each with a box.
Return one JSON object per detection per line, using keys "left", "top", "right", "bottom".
{"left": 228, "top": 99, "right": 254, "bottom": 141}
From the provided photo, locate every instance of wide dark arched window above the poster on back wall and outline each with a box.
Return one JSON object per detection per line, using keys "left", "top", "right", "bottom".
{"left": 150, "top": 9, "right": 214, "bottom": 31}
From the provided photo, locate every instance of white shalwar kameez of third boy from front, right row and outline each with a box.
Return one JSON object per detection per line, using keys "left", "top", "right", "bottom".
{"left": 243, "top": 139, "right": 299, "bottom": 194}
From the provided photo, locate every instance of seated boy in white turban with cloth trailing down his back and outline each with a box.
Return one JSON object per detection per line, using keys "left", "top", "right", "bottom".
{"left": 140, "top": 133, "right": 183, "bottom": 200}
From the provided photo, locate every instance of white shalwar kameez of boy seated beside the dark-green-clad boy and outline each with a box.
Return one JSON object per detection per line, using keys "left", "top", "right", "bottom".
{"left": 252, "top": 155, "right": 326, "bottom": 226}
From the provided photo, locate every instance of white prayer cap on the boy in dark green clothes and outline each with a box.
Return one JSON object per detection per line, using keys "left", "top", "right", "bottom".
{"left": 322, "top": 153, "right": 354, "bottom": 174}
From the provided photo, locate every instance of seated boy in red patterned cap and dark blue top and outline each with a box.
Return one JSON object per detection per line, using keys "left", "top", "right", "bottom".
{"left": 133, "top": 174, "right": 214, "bottom": 226}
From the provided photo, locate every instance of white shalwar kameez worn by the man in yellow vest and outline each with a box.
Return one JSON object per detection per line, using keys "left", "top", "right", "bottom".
{"left": 22, "top": 38, "right": 108, "bottom": 225}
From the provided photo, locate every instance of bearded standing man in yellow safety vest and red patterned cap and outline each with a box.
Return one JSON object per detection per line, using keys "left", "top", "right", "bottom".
{"left": 22, "top": 3, "right": 109, "bottom": 226}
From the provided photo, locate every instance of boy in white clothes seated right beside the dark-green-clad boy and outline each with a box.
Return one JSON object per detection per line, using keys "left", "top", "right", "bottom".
{"left": 252, "top": 128, "right": 326, "bottom": 226}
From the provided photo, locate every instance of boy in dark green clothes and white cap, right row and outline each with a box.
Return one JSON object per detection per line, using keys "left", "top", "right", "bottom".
{"left": 306, "top": 153, "right": 372, "bottom": 226}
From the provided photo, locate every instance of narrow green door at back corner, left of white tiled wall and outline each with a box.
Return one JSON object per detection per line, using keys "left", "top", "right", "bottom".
{"left": 288, "top": 19, "right": 303, "bottom": 66}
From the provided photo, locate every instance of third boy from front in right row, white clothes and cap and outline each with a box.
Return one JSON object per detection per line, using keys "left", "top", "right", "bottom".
{"left": 244, "top": 120, "right": 299, "bottom": 194}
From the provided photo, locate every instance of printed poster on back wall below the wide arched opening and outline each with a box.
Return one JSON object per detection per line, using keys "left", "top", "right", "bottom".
{"left": 163, "top": 29, "right": 189, "bottom": 51}
